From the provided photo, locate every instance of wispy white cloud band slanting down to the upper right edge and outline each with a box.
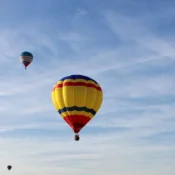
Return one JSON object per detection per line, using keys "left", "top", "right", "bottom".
{"left": 105, "top": 12, "right": 175, "bottom": 57}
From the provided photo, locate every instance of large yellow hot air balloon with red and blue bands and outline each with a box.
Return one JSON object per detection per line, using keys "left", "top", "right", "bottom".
{"left": 52, "top": 75, "right": 103, "bottom": 140}
